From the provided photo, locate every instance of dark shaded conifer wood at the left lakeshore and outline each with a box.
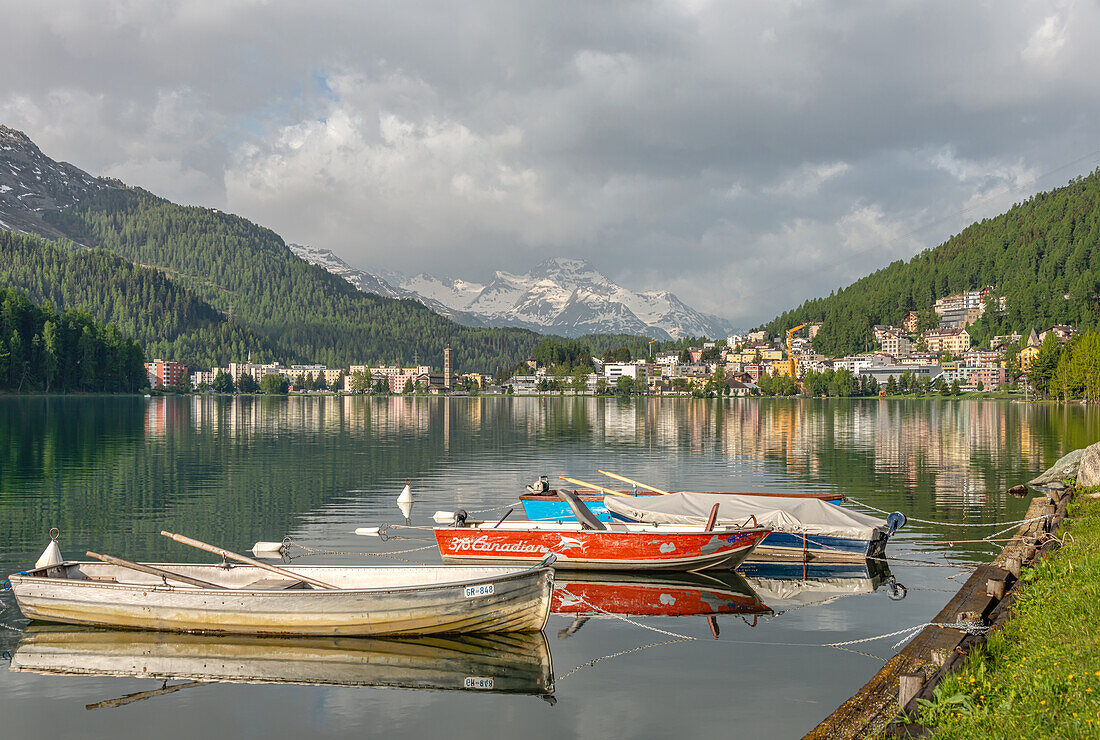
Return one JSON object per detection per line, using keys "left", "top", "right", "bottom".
{"left": 0, "top": 288, "right": 147, "bottom": 393}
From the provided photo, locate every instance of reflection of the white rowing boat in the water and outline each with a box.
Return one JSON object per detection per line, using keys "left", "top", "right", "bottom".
{"left": 11, "top": 625, "right": 554, "bottom": 708}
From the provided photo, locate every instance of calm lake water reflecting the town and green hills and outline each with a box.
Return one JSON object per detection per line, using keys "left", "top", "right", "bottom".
{"left": 0, "top": 397, "right": 1100, "bottom": 740}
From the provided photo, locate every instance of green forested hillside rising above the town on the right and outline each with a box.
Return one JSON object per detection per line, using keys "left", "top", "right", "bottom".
{"left": 763, "top": 170, "right": 1100, "bottom": 356}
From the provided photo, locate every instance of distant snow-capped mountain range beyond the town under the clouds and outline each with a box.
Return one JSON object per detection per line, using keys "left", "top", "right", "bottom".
{"left": 290, "top": 245, "right": 729, "bottom": 339}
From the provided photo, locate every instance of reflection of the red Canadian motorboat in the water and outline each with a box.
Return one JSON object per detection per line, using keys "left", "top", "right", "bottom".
{"left": 550, "top": 571, "right": 771, "bottom": 639}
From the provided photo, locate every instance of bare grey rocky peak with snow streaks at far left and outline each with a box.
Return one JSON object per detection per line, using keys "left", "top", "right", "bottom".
{"left": 0, "top": 125, "right": 112, "bottom": 235}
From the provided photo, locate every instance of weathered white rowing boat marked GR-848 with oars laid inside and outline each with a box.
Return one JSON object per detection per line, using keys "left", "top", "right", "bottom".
{"left": 10, "top": 559, "right": 553, "bottom": 636}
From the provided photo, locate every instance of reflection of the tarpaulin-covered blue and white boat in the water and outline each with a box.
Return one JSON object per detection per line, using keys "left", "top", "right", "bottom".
{"left": 739, "top": 560, "right": 905, "bottom": 615}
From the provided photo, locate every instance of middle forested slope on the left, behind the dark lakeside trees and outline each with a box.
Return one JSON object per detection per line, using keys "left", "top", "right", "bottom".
{"left": 0, "top": 232, "right": 283, "bottom": 366}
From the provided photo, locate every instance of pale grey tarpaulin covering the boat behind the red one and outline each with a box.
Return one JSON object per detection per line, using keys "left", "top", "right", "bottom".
{"left": 604, "top": 493, "right": 888, "bottom": 540}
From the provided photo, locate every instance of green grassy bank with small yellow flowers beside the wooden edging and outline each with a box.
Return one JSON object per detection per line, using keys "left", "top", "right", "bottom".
{"left": 920, "top": 494, "right": 1100, "bottom": 740}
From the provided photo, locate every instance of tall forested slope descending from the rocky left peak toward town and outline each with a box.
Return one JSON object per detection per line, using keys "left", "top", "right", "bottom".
{"left": 44, "top": 188, "right": 542, "bottom": 369}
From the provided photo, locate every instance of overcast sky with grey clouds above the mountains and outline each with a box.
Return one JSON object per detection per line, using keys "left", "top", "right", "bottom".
{"left": 0, "top": 0, "right": 1100, "bottom": 325}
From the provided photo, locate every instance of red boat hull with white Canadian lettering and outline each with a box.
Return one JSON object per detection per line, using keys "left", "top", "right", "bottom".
{"left": 435, "top": 522, "right": 770, "bottom": 571}
